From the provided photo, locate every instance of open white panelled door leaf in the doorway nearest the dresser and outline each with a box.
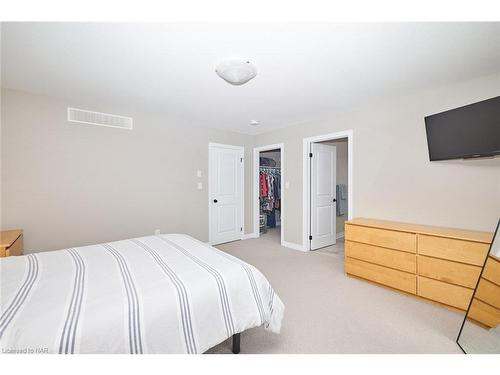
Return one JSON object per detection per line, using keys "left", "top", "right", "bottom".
{"left": 310, "top": 143, "right": 337, "bottom": 250}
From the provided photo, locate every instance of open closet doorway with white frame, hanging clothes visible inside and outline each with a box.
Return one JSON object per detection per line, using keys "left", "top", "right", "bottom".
{"left": 254, "top": 144, "right": 284, "bottom": 245}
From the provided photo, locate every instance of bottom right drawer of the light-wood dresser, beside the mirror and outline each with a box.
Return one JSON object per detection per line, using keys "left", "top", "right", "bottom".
{"left": 417, "top": 276, "right": 473, "bottom": 310}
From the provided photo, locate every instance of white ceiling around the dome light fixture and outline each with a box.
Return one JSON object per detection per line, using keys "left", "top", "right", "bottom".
{"left": 2, "top": 23, "right": 500, "bottom": 134}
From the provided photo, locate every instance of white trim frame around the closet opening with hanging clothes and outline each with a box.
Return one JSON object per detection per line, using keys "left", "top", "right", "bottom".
{"left": 252, "top": 143, "right": 286, "bottom": 246}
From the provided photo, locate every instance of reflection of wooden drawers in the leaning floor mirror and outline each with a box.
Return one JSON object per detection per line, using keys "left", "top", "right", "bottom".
{"left": 467, "top": 255, "right": 500, "bottom": 328}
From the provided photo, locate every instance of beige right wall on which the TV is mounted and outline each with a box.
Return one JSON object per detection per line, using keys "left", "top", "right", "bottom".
{"left": 255, "top": 74, "right": 500, "bottom": 244}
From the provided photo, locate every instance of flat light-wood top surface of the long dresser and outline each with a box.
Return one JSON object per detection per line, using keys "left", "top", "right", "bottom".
{"left": 346, "top": 217, "right": 493, "bottom": 244}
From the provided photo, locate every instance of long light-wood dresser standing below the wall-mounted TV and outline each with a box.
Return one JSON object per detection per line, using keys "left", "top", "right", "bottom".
{"left": 345, "top": 218, "right": 493, "bottom": 311}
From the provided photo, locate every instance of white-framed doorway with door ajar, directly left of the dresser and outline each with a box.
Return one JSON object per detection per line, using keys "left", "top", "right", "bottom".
{"left": 303, "top": 131, "right": 353, "bottom": 254}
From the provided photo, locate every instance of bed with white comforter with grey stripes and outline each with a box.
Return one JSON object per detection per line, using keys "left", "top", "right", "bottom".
{"left": 0, "top": 234, "right": 284, "bottom": 354}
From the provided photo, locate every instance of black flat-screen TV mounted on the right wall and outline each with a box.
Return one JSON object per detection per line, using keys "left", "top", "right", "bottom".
{"left": 425, "top": 96, "right": 500, "bottom": 161}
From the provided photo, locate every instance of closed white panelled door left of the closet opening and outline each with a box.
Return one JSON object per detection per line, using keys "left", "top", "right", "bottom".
{"left": 209, "top": 145, "right": 243, "bottom": 245}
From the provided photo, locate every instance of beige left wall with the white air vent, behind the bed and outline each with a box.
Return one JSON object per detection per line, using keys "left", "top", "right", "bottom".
{"left": 1, "top": 90, "right": 253, "bottom": 252}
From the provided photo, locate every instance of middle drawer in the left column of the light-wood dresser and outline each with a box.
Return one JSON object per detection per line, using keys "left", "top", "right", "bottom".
{"left": 345, "top": 241, "right": 417, "bottom": 273}
